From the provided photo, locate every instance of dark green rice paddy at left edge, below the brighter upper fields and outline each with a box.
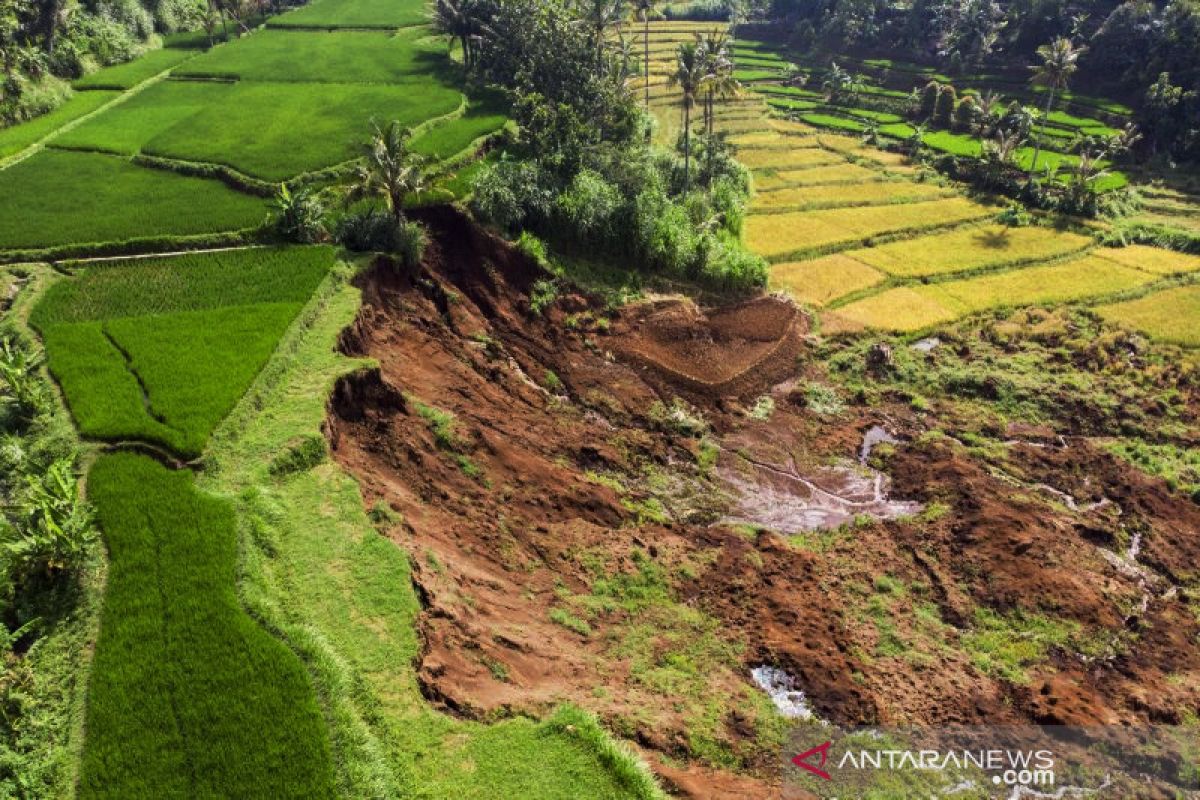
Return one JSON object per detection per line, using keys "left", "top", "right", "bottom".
{"left": 0, "top": 150, "right": 266, "bottom": 249}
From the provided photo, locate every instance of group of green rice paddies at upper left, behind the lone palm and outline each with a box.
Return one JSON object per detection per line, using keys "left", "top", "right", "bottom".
{"left": 0, "top": 0, "right": 506, "bottom": 249}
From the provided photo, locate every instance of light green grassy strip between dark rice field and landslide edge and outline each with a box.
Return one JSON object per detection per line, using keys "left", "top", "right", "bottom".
{"left": 202, "top": 272, "right": 661, "bottom": 800}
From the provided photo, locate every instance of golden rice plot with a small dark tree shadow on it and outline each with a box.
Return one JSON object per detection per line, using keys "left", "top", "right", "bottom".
{"left": 851, "top": 224, "right": 1094, "bottom": 277}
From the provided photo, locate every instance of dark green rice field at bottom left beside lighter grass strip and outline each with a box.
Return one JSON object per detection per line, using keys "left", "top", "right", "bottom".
{"left": 79, "top": 455, "right": 334, "bottom": 800}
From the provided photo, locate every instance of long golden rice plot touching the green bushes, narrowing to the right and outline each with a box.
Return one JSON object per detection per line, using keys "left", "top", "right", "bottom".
{"left": 745, "top": 197, "right": 992, "bottom": 260}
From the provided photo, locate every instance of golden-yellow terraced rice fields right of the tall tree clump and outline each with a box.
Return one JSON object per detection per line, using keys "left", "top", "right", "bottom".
{"left": 635, "top": 23, "right": 1200, "bottom": 345}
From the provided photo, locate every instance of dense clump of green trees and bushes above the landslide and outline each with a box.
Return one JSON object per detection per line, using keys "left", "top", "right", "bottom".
{"left": 437, "top": 0, "right": 766, "bottom": 288}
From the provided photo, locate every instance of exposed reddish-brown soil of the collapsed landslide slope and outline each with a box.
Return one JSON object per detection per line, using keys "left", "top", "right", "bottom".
{"left": 329, "top": 209, "right": 1200, "bottom": 796}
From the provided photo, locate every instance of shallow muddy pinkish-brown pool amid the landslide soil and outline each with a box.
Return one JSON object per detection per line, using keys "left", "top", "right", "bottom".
{"left": 718, "top": 455, "right": 922, "bottom": 534}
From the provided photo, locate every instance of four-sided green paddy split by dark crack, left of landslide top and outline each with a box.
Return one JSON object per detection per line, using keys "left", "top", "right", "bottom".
{"left": 31, "top": 247, "right": 332, "bottom": 457}
